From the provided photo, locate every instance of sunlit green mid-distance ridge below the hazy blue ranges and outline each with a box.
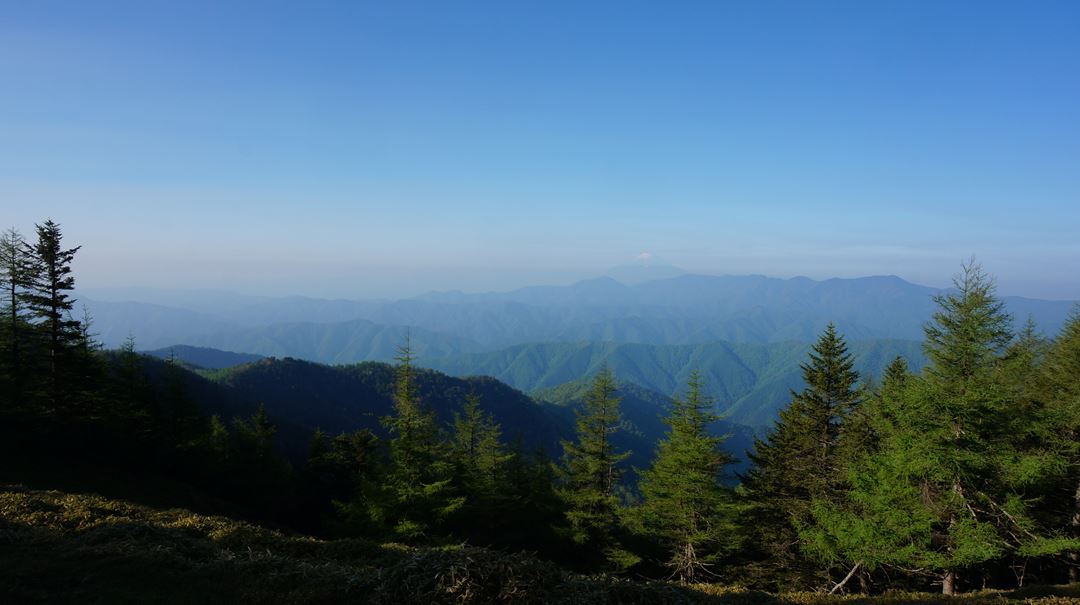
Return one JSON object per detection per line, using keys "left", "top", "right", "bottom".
{"left": 423, "top": 340, "right": 923, "bottom": 428}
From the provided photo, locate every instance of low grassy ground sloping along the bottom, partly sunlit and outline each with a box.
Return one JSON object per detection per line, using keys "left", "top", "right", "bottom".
{"left": 0, "top": 485, "right": 1080, "bottom": 605}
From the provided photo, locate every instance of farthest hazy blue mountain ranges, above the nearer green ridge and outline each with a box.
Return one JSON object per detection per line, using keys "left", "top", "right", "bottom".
{"left": 82, "top": 274, "right": 1074, "bottom": 352}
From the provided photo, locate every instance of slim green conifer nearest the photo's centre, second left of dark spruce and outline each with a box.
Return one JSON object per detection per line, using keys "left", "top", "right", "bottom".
{"left": 559, "top": 367, "right": 636, "bottom": 568}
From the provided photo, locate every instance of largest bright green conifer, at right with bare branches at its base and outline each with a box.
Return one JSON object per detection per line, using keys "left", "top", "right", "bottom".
{"left": 813, "top": 264, "right": 1067, "bottom": 594}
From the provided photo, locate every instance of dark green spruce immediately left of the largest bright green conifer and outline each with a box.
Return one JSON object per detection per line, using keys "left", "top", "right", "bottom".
{"left": 743, "top": 323, "right": 862, "bottom": 588}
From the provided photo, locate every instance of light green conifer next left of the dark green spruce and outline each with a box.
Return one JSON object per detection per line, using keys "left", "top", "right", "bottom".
{"left": 635, "top": 372, "right": 739, "bottom": 582}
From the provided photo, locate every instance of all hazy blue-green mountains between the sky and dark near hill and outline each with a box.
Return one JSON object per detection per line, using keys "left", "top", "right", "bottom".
{"left": 81, "top": 272, "right": 1074, "bottom": 429}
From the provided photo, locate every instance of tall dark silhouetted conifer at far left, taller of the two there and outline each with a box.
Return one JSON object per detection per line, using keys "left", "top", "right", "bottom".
{"left": 23, "top": 220, "right": 83, "bottom": 411}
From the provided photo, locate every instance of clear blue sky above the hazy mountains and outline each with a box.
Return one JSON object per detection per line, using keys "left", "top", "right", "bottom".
{"left": 0, "top": 0, "right": 1080, "bottom": 298}
